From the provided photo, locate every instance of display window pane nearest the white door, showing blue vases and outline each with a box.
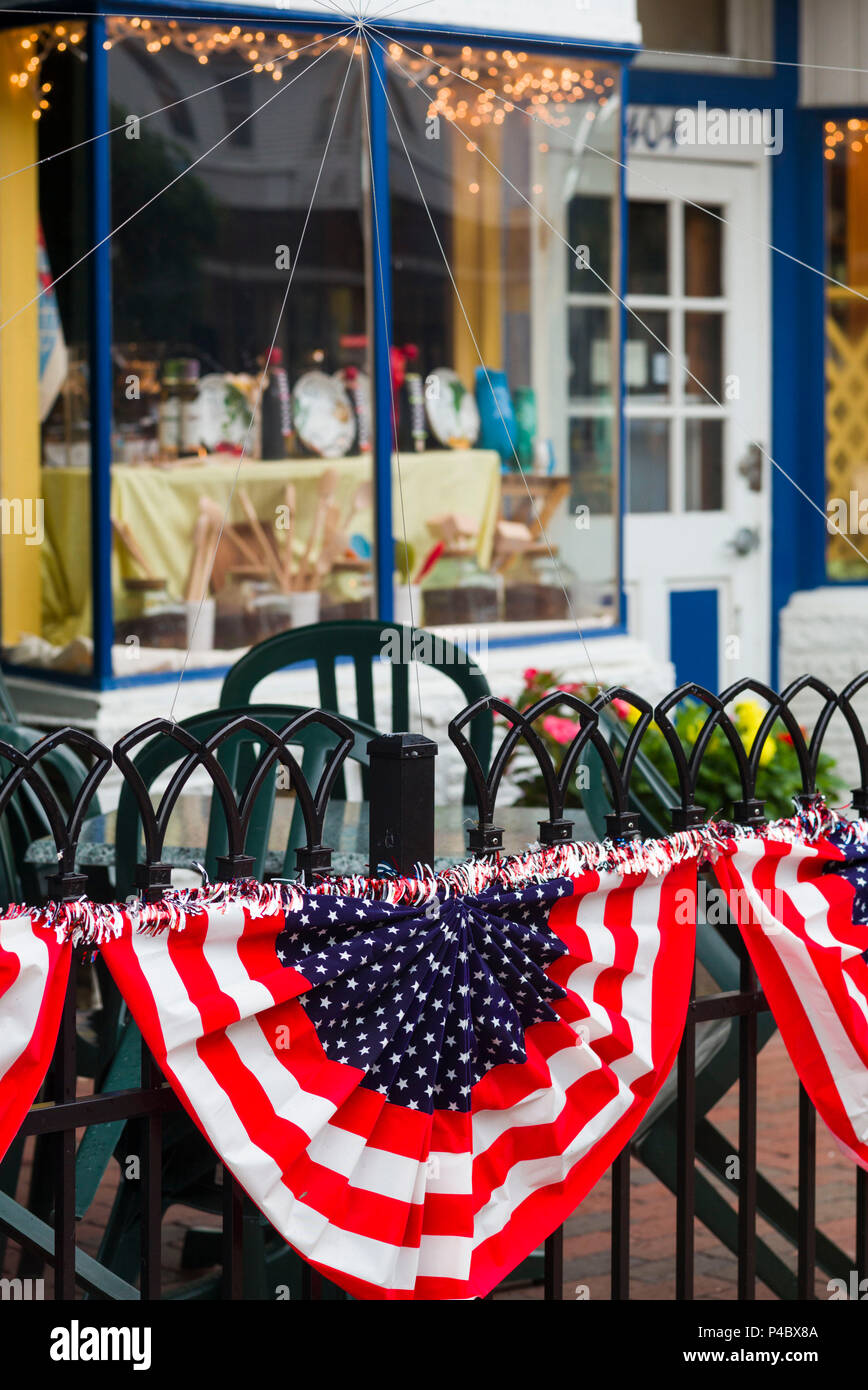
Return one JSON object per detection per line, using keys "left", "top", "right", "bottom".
{"left": 388, "top": 43, "right": 619, "bottom": 626}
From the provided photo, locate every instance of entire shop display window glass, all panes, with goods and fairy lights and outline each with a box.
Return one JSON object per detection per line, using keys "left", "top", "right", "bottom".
{"left": 0, "top": 15, "right": 625, "bottom": 692}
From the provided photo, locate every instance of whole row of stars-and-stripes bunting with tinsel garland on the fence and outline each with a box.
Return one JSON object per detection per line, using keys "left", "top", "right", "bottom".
{"left": 0, "top": 806, "right": 868, "bottom": 1300}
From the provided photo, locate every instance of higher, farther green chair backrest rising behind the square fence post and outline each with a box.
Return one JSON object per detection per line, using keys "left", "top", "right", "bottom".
{"left": 220, "top": 620, "right": 494, "bottom": 805}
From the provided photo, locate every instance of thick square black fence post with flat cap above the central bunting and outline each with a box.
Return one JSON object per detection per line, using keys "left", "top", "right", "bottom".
{"left": 367, "top": 734, "right": 437, "bottom": 876}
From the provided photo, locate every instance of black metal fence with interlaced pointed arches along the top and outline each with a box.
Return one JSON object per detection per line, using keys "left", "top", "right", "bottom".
{"left": 0, "top": 673, "right": 868, "bottom": 1300}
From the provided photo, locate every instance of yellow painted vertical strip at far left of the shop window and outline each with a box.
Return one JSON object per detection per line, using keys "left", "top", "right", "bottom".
{"left": 0, "top": 33, "right": 42, "bottom": 644}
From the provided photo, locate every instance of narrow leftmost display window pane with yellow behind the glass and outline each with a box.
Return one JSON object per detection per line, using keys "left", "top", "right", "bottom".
{"left": 0, "top": 24, "right": 93, "bottom": 676}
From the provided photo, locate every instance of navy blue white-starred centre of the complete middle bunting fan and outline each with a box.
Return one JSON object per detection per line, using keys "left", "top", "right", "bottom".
{"left": 271, "top": 881, "right": 570, "bottom": 1113}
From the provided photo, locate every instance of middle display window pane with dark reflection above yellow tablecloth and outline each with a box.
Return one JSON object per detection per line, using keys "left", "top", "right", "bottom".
{"left": 109, "top": 19, "right": 374, "bottom": 674}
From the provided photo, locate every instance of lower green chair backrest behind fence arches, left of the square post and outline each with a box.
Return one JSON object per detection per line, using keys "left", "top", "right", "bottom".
{"left": 115, "top": 705, "right": 377, "bottom": 897}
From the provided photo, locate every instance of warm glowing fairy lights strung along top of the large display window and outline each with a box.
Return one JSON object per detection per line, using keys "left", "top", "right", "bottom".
{"left": 10, "top": 15, "right": 615, "bottom": 128}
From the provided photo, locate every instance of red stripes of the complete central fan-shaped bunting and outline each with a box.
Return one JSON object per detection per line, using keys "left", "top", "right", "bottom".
{"left": 106, "top": 873, "right": 693, "bottom": 1300}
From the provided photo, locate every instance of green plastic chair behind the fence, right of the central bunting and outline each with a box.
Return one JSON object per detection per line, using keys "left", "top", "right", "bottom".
{"left": 579, "top": 710, "right": 853, "bottom": 1300}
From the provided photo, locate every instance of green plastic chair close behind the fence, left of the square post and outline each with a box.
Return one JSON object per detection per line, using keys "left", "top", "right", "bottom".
{"left": 81, "top": 705, "right": 377, "bottom": 1298}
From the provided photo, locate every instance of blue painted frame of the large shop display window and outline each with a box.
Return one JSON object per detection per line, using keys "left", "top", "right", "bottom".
{"left": 0, "top": 0, "right": 640, "bottom": 691}
